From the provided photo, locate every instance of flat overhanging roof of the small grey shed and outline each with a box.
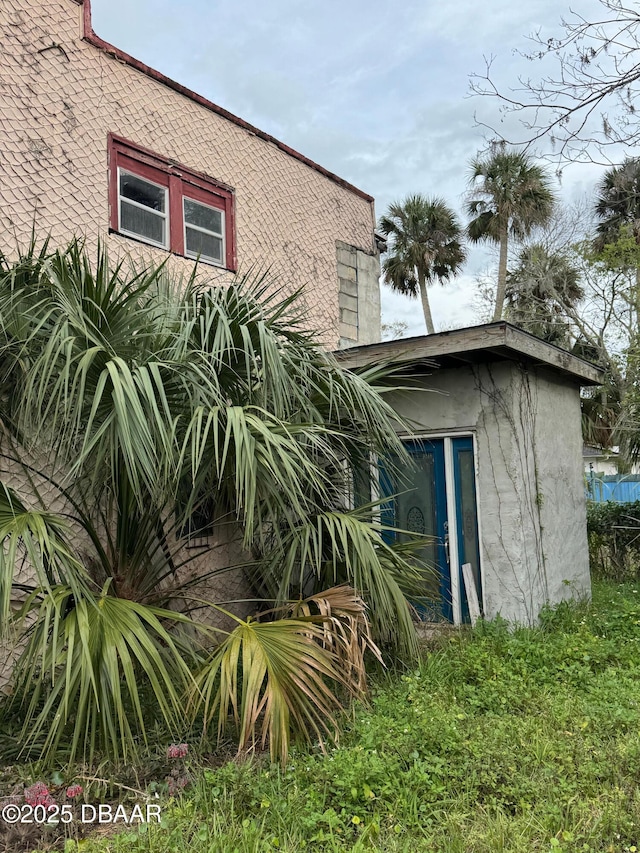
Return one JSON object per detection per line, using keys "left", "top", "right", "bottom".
{"left": 334, "top": 320, "right": 604, "bottom": 385}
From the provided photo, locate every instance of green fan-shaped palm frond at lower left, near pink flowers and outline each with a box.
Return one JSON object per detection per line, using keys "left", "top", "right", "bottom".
{"left": 15, "top": 585, "right": 193, "bottom": 760}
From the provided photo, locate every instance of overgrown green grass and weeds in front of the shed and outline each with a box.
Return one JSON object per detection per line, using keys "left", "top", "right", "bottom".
{"left": 47, "top": 584, "right": 640, "bottom": 853}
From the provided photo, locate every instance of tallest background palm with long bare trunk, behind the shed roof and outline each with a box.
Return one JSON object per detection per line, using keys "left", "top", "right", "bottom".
{"left": 467, "top": 149, "right": 555, "bottom": 320}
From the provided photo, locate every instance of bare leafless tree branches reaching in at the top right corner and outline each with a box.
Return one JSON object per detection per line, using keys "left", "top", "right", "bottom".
{"left": 470, "top": 0, "right": 640, "bottom": 167}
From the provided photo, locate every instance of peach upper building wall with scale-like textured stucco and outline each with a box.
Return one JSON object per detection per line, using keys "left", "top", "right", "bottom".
{"left": 0, "top": 0, "right": 379, "bottom": 348}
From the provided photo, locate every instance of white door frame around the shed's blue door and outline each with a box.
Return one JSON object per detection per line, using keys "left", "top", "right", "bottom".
{"left": 398, "top": 429, "right": 486, "bottom": 625}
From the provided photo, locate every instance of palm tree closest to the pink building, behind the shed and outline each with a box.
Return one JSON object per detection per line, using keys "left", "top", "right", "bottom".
{"left": 379, "top": 194, "right": 466, "bottom": 335}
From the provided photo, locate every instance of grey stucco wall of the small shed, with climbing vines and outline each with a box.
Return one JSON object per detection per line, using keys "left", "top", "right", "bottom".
{"left": 384, "top": 363, "right": 590, "bottom": 624}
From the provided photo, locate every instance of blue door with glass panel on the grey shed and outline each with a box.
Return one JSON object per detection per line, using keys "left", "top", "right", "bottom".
{"left": 380, "top": 436, "right": 482, "bottom": 622}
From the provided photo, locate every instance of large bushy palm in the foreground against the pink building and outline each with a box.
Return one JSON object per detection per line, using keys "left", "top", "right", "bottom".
{"left": 0, "top": 243, "right": 422, "bottom": 759}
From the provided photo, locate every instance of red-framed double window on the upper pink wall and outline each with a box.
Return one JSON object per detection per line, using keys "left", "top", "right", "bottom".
{"left": 108, "top": 134, "right": 236, "bottom": 270}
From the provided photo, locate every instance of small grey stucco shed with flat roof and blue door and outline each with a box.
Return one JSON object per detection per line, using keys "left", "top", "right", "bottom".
{"left": 336, "top": 322, "right": 602, "bottom": 625}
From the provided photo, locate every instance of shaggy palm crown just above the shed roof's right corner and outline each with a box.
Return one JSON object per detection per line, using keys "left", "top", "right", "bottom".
{"left": 506, "top": 243, "right": 584, "bottom": 346}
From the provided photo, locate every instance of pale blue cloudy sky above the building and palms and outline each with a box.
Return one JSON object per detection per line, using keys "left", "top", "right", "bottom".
{"left": 92, "top": 0, "right": 612, "bottom": 334}
